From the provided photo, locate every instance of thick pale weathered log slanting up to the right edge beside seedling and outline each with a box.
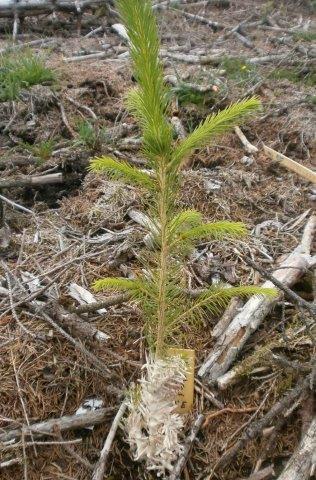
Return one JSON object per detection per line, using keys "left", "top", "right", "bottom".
{"left": 198, "top": 216, "right": 316, "bottom": 383}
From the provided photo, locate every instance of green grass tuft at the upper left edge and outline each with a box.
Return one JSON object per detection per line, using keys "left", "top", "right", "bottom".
{"left": 0, "top": 50, "right": 55, "bottom": 102}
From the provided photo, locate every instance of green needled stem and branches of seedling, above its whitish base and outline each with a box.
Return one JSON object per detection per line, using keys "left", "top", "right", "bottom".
{"left": 91, "top": 0, "right": 273, "bottom": 357}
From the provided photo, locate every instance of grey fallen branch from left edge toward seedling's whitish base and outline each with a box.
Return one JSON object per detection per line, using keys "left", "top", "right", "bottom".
{"left": 0, "top": 407, "right": 116, "bottom": 443}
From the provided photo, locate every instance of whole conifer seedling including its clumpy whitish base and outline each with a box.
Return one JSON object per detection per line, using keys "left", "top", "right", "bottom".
{"left": 91, "top": 0, "right": 274, "bottom": 476}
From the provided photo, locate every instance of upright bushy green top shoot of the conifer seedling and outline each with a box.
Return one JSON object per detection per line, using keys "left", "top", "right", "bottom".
{"left": 117, "top": 0, "right": 172, "bottom": 159}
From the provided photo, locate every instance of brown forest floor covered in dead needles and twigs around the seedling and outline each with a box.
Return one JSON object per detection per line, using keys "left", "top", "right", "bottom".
{"left": 0, "top": 0, "right": 316, "bottom": 480}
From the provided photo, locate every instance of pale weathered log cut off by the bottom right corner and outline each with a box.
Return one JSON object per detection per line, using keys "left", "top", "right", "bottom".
{"left": 278, "top": 418, "right": 316, "bottom": 480}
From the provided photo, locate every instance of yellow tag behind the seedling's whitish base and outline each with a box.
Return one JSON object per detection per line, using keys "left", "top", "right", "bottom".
{"left": 168, "top": 348, "right": 195, "bottom": 413}
